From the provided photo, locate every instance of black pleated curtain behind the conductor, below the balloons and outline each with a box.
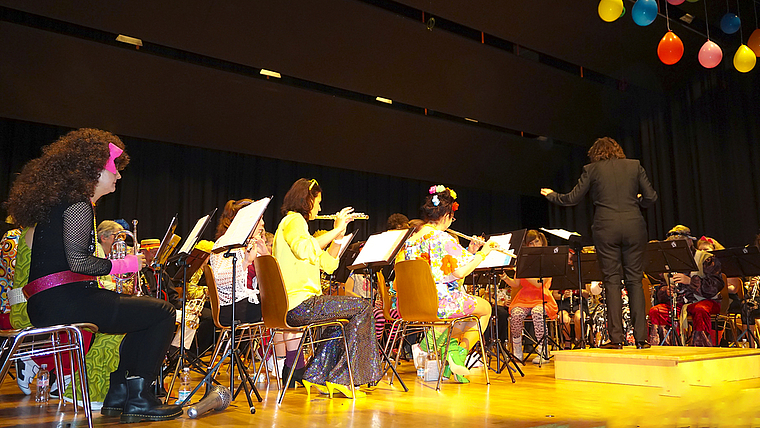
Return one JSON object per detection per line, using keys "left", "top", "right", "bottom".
{"left": 549, "top": 66, "right": 760, "bottom": 247}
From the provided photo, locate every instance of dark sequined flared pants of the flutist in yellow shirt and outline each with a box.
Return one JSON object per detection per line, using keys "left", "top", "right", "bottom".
{"left": 287, "top": 296, "right": 382, "bottom": 385}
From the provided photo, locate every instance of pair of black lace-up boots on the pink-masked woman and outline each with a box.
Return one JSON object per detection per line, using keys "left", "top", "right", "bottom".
{"left": 100, "top": 373, "right": 182, "bottom": 423}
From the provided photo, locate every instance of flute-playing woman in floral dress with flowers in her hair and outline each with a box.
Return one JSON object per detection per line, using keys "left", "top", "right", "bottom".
{"left": 396, "top": 185, "right": 494, "bottom": 383}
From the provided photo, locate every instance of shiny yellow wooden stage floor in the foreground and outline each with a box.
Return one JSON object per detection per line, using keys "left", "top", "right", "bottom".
{"left": 0, "top": 352, "right": 760, "bottom": 428}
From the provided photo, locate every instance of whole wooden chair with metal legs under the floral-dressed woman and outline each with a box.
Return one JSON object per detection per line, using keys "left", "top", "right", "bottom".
{"left": 394, "top": 260, "right": 491, "bottom": 391}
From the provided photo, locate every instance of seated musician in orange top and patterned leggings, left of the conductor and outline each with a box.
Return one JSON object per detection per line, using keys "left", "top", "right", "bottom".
{"left": 503, "top": 230, "right": 557, "bottom": 364}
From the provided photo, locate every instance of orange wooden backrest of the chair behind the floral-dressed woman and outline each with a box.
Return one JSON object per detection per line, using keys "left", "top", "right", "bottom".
{"left": 393, "top": 259, "right": 439, "bottom": 322}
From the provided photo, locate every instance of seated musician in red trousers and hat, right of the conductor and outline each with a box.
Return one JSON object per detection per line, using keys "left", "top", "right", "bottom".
{"left": 649, "top": 225, "right": 725, "bottom": 346}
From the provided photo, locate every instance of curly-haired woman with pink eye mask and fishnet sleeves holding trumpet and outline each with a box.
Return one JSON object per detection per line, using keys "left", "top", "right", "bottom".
{"left": 7, "top": 128, "right": 182, "bottom": 422}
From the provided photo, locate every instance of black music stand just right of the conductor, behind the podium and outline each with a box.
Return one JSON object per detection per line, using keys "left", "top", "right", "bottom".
{"left": 644, "top": 239, "right": 697, "bottom": 345}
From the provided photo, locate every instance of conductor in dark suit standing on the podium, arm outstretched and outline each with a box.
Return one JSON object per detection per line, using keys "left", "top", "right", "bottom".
{"left": 541, "top": 137, "right": 657, "bottom": 349}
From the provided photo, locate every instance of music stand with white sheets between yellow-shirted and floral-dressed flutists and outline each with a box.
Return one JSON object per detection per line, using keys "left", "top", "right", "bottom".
{"left": 348, "top": 229, "right": 414, "bottom": 392}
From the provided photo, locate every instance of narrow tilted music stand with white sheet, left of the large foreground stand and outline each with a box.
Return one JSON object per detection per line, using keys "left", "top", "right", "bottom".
{"left": 165, "top": 208, "right": 216, "bottom": 406}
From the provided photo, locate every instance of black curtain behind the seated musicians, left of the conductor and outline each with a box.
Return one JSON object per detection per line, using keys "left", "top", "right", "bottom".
{"left": 0, "top": 119, "right": 549, "bottom": 244}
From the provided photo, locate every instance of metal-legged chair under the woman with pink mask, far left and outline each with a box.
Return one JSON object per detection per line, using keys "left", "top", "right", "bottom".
{"left": 0, "top": 323, "right": 98, "bottom": 428}
